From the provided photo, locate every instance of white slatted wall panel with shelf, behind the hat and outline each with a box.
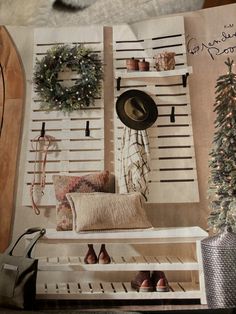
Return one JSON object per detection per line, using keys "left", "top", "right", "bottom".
{"left": 113, "top": 17, "right": 199, "bottom": 203}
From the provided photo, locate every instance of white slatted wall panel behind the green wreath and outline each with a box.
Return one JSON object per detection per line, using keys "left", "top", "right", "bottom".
{"left": 23, "top": 26, "right": 104, "bottom": 205}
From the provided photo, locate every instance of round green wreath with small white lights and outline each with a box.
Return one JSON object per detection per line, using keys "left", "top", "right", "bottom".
{"left": 33, "top": 45, "right": 102, "bottom": 112}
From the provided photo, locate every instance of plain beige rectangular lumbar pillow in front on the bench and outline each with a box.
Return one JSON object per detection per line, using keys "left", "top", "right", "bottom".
{"left": 66, "top": 193, "right": 152, "bottom": 232}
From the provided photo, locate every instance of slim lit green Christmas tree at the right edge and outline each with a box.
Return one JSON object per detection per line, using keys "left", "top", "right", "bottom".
{"left": 208, "top": 58, "right": 236, "bottom": 231}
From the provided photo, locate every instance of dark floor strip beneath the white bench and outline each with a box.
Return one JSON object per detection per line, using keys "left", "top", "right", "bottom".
{"left": 0, "top": 300, "right": 236, "bottom": 314}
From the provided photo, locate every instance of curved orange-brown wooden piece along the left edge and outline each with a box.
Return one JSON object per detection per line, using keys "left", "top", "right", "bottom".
{"left": 0, "top": 26, "right": 25, "bottom": 251}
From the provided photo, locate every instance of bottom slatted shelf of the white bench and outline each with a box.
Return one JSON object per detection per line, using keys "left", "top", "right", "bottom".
{"left": 37, "top": 282, "right": 201, "bottom": 300}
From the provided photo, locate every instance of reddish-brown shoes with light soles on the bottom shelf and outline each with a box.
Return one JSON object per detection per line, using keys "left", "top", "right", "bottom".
{"left": 131, "top": 271, "right": 170, "bottom": 292}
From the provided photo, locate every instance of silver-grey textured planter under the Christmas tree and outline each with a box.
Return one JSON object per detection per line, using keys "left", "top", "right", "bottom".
{"left": 201, "top": 228, "right": 236, "bottom": 308}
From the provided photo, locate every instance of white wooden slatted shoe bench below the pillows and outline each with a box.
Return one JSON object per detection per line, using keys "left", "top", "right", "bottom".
{"left": 27, "top": 227, "right": 207, "bottom": 304}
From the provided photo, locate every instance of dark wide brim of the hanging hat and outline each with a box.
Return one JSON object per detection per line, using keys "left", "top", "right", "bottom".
{"left": 116, "top": 89, "right": 158, "bottom": 130}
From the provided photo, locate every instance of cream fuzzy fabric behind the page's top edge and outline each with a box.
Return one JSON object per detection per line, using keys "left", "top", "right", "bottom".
{"left": 0, "top": 0, "right": 204, "bottom": 26}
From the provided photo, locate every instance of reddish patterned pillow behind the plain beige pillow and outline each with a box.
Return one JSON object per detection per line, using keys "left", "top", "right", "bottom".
{"left": 52, "top": 171, "right": 109, "bottom": 231}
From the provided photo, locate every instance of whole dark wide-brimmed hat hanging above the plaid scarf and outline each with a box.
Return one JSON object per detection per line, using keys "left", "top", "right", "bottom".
{"left": 116, "top": 89, "right": 158, "bottom": 130}
